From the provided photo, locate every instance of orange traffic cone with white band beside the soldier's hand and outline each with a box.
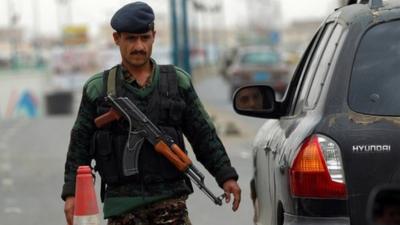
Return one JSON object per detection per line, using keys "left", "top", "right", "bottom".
{"left": 74, "top": 166, "right": 100, "bottom": 225}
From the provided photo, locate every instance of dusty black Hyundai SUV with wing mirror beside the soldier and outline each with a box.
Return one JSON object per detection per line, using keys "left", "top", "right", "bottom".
{"left": 233, "top": 0, "right": 400, "bottom": 225}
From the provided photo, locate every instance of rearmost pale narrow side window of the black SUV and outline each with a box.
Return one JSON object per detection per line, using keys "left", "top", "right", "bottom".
{"left": 305, "top": 24, "right": 343, "bottom": 108}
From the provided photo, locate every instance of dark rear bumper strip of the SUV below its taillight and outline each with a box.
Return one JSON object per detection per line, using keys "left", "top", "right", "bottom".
{"left": 283, "top": 213, "right": 350, "bottom": 225}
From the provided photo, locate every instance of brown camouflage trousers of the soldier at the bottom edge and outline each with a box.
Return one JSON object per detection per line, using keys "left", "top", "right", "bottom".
{"left": 108, "top": 197, "right": 191, "bottom": 225}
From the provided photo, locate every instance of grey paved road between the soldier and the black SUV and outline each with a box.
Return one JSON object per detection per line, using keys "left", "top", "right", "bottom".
{"left": 188, "top": 73, "right": 262, "bottom": 225}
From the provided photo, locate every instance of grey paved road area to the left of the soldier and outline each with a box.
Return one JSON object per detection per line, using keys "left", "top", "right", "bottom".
{"left": 0, "top": 117, "right": 72, "bottom": 225}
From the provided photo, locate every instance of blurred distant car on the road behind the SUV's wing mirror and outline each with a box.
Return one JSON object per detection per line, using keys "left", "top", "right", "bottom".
{"left": 225, "top": 46, "right": 290, "bottom": 96}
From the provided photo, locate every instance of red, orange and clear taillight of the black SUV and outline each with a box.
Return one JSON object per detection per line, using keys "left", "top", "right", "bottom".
{"left": 290, "top": 135, "right": 347, "bottom": 199}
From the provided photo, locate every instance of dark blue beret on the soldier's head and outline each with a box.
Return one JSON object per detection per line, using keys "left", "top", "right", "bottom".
{"left": 111, "top": 2, "right": 154, "bottom": 34}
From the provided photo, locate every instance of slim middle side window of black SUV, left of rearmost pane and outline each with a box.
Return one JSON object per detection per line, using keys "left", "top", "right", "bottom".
{"left": 294, "top": 23, "right": 334, "bottom": 114}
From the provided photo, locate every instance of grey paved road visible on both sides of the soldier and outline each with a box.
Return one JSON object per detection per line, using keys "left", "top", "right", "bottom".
{"left": 0, "top": 74, "right": 266, "bottom": 225}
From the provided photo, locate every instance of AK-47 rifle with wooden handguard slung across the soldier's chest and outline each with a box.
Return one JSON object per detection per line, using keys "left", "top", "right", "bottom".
{"left": 95, "top": 95, "right": 225, "bottom": 205}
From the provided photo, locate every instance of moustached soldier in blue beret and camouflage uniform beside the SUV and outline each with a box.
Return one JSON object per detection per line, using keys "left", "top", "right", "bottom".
{"left": 61, "top": 2, "right": 241, "bottom": 225}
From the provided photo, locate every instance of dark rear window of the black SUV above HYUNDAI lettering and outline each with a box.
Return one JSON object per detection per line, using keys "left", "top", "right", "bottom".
{"left": 349, "top": 21, "right": 400, "bottom": 116}
